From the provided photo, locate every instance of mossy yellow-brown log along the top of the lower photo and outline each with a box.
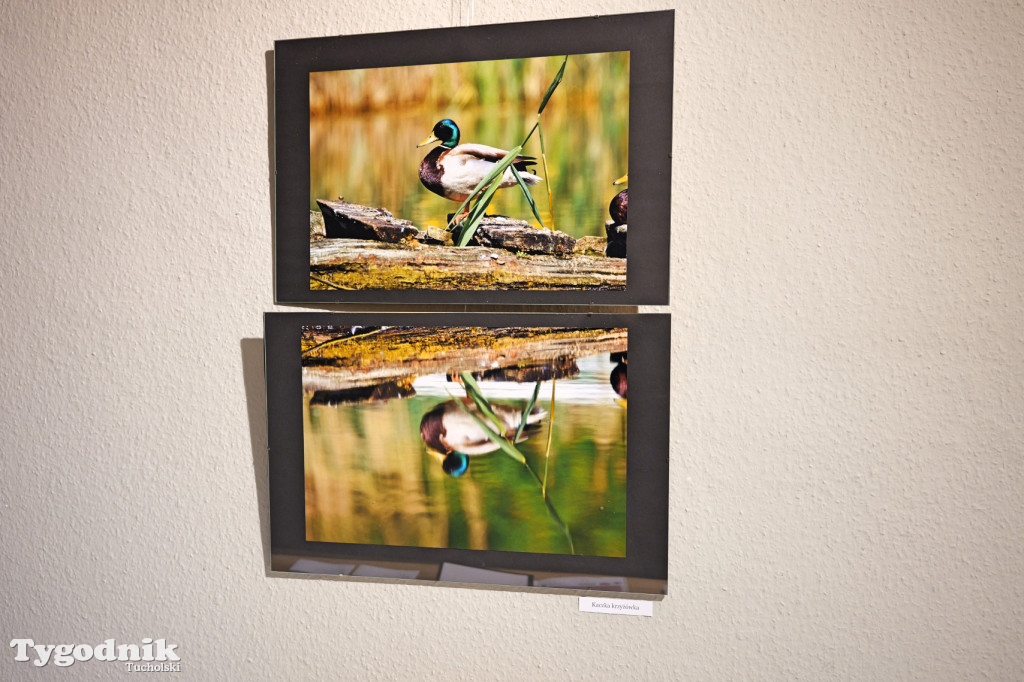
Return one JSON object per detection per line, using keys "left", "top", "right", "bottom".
{"left": 301, "top": 327, "right": 627, "bottom": 391}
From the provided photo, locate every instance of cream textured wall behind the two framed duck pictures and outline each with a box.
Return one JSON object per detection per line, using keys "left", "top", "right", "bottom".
{"left": 0, "top": 0, "right": 1024, "bottom": 680}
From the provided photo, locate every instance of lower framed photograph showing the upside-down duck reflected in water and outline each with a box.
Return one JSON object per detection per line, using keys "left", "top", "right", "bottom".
{"left": 265, "top": 312, "right": 671, "bottom": 594}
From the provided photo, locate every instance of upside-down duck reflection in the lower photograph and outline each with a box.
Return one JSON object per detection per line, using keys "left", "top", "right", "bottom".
{"left": 420, "top": 398, "right": 548, "bottom": 477}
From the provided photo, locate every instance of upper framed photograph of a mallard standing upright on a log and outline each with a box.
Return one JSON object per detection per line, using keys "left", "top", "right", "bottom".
{"left": 273, "top": 10, "right": 674, "bottom": 305}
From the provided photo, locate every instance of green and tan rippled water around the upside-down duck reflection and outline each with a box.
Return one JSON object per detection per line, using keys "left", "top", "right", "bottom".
{"left": 303, "top": 355, "right": 626, "bottom": 556}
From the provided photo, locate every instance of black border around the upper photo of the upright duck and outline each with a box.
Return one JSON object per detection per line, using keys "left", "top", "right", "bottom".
{"left": 273, "top": 10, "right": 675, "bottom": 305}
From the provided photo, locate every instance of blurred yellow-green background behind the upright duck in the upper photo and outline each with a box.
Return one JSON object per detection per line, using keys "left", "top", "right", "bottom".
{"left": 309, "top": 52, "right": 630, "bottom": 238}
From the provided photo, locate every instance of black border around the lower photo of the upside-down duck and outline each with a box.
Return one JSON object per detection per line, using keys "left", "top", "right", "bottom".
{"left": 264, "top": 312, "right": 671, "bottom": 594}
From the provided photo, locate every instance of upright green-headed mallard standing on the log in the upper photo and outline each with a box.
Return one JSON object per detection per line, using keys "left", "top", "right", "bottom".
{"left": 416, "top": 119, "right": 541, "bottom": 202}
